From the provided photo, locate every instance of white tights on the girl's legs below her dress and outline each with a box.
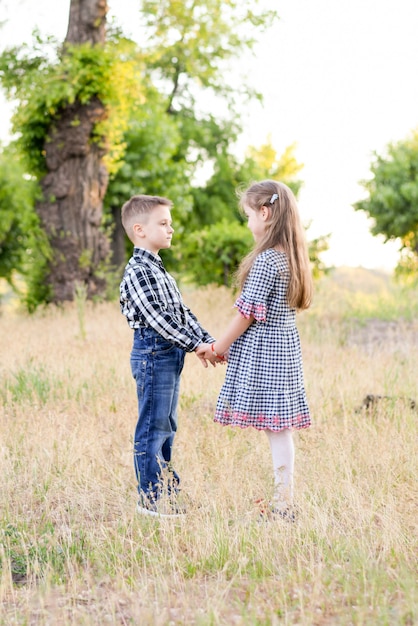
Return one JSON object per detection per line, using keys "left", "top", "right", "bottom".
{"left": 265, "top": 428, "right": 295, "bottom": 508}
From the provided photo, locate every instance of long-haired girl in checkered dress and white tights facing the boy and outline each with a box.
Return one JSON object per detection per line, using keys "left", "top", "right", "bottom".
{"left": 197, "top": 180, "right": 312, "bottom": 520}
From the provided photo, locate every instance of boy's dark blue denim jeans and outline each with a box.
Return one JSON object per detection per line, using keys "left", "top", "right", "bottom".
{"left": 131, "top": 328, "right": 185, "bottom": 502}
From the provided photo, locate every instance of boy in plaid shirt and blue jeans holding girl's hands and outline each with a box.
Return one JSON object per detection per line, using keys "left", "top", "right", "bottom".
{"left": 120, "top": 195, "right": 217, "bottom": 517}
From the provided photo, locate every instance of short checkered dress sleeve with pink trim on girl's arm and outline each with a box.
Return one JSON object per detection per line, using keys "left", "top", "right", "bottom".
{"left": 234, "top": 253, "right": 279, "bottom": 322}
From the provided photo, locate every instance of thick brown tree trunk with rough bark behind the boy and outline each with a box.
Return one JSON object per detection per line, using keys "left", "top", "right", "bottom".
{"left": 37, "top": 0, "right": 109, "bottom": 303}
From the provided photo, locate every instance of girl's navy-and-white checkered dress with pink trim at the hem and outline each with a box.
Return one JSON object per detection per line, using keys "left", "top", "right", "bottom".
{"left": 215, "top": 249, "right": 311, "bottom": 431}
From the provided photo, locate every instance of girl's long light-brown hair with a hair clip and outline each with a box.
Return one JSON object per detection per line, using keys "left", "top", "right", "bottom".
{"left": 237, "top": 180, "right": 313, "bottom": 310}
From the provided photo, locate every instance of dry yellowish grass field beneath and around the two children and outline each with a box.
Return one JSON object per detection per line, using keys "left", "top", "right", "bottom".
{"left": 0, "top": 269, "right": 418, "bottom": 626}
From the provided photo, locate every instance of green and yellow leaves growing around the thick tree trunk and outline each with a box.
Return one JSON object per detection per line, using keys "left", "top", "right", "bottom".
{"left": 0, "top": 34, "right": 144, "bottom": 310}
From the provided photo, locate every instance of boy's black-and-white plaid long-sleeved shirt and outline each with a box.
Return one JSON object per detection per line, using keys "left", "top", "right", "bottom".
{"left": 120, "top": 248, "right": 214, "bottom": 352}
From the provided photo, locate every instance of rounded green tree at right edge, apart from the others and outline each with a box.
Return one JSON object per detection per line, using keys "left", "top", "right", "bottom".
{"left": 354, "top": 131, "right": 418, "bottom": 274}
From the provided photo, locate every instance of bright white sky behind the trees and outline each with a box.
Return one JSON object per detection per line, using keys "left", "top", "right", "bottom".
{"left": 0, "top": 0, "right": 418, "bottom": 269}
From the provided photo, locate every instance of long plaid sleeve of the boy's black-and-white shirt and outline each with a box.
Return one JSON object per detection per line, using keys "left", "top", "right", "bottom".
{"left": 121, "top": 266, "right": 212, "bottom": 352}
